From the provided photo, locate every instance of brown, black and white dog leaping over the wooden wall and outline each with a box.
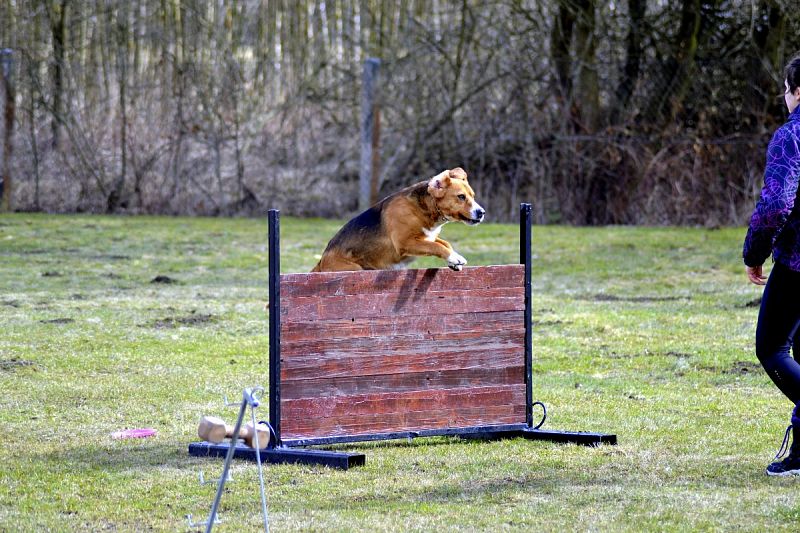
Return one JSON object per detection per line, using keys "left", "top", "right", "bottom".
{"left": 312, "top": 168, "right": 486, "bottom": 272}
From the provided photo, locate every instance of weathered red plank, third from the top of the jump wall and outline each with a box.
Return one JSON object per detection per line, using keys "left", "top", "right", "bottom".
{"left": 281, "top": 311, "right": 525, "bottom": 347}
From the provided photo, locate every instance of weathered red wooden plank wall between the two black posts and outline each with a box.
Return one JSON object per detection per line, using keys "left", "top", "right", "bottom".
{"left": 281, "top": 265, "right": 526, "bottom": 439}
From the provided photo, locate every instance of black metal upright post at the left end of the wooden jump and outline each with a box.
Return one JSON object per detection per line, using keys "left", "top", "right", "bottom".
{"left": 269, "top": 209, "right": 281, "bottom": 446}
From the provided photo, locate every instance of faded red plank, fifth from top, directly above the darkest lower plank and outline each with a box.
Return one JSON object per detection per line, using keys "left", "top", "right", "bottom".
{"left": 281, "top": 345, "right": 524, "bottom": 383}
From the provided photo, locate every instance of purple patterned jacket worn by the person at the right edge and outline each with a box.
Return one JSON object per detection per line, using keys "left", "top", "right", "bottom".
{"left": 742, "top": 106, "right": 800, "bottom": 271}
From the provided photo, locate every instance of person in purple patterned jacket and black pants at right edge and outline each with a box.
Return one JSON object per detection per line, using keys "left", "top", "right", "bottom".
{"left": 743, "top": 55, "right": 800, "bottom": 476}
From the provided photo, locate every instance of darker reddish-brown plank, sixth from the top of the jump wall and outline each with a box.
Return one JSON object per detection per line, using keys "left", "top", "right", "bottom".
{"left": 281, "top": 366, "right": 525, "bottom": 400}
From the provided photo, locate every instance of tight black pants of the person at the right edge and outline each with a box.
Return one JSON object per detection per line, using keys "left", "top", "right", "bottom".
{"left": 756, "top": 263, "right": 800, "bottom": 431}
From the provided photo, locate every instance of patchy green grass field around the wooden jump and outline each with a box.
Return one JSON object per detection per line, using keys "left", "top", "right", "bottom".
{"left": 0, "top": 214, "right": 800, "bottom": 531}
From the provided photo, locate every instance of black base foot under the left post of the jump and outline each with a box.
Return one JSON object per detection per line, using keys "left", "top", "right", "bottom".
{"left": 189, "top": 442, "right": 365, "bottom": 470}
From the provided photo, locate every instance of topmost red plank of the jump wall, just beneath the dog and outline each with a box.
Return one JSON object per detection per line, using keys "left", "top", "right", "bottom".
{"left": 281, "top": 265, "right": 525, "bottom": 297}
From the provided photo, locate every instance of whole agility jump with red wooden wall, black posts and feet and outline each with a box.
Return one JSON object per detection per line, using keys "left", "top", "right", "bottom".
{"left": 189, "top": 204, "right": 617, "bottom": 468}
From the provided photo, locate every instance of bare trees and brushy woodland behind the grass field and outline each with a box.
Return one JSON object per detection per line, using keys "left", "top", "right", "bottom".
{"left": 0, "top": 0, "right": 800, "bottom": 226}
